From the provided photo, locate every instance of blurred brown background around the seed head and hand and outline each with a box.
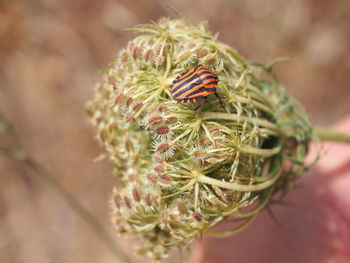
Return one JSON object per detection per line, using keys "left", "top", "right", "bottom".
{"left": 0, "top": 0, "right": 350, "bottom": 263}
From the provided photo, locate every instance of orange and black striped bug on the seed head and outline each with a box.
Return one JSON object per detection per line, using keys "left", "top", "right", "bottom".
{"left": 170, "top": 65, "right": 224, "bottom": 110}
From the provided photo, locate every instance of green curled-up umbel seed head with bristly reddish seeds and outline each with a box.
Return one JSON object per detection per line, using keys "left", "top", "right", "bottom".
{"left": 87, "top": 19, "right": 313, "bottom": 260}
